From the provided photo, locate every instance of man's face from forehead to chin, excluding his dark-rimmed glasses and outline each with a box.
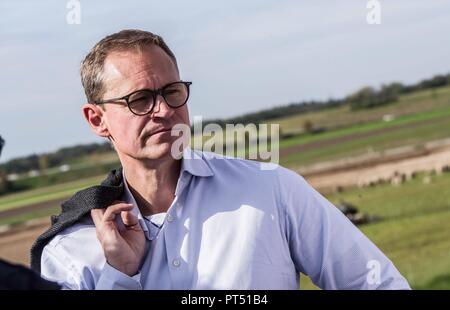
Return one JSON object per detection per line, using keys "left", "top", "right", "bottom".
{"left": 94, "top": 45, "right": 189, "bottom": 160}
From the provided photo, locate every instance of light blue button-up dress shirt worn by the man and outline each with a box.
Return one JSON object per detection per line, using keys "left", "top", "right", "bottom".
{"left": 41, "top": 148, "right": 409, "bottom": 289}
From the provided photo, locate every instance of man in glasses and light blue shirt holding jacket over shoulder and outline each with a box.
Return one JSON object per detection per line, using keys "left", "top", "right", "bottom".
{"left": 32, "top": 30, "right": 409, "bottom": 289}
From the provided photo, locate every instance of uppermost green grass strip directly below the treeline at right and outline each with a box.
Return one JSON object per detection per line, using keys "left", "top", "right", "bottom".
{"left": 192, "top": 86, "right": 450, "bottom": 153}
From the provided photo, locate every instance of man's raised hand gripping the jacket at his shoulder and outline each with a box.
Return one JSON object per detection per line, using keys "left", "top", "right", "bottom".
{"left": 91, "top": 201, "right": 145, "bottom": 276}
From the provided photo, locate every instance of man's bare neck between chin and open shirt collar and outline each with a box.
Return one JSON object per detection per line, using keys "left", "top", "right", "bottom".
{"left": 122, "top": 156, "right": 181, "bottom": 216}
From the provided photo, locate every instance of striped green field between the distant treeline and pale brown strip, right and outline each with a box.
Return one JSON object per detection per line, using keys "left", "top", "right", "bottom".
{"left": 195, "top": 87, "right": 450, "bottom": 168}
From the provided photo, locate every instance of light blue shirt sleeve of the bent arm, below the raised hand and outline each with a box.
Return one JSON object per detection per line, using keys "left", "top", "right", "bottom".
{"left": 41, "top": 245, "right": 142, "bottom": 290}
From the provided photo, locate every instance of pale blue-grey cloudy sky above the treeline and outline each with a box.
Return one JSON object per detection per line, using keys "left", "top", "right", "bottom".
{"left": 0, "top": 0, "right": 450, "bottom": 163}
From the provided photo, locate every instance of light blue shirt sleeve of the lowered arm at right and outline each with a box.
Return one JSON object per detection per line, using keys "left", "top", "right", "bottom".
{"left": 277, "top": 167, "right": 410, "bottom": 289}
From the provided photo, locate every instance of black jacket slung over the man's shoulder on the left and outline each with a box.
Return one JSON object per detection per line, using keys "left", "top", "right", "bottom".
{"left": 31, "top": 168, "right": 124, "bottom": 273}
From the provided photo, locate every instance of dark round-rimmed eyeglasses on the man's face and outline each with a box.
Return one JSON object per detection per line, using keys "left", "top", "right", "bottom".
{"left": 94, "top": 81, "right": 192, "bottom": 116}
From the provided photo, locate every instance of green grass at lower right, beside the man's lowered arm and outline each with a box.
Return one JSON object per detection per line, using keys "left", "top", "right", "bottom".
{"left": 301, "top": 173, "right": 450, "bottom": 289}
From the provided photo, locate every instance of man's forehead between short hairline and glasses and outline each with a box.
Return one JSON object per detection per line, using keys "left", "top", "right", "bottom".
{"left": 103, "top": 45, "right": 179, "bottom": 93}
